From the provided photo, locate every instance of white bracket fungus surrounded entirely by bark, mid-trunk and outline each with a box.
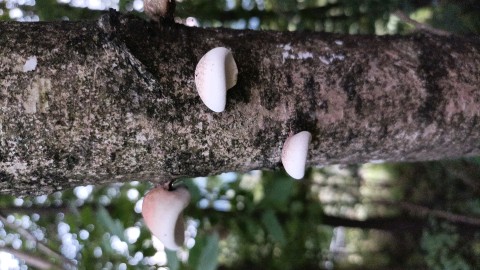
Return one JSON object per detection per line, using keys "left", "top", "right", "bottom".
{"left": 195, "top": 47, "right": 238, "bottom": 112}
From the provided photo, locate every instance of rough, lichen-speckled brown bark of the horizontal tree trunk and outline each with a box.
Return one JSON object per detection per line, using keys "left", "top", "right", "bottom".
{"left": 0, "top": 12, "right": 480, "bottom": 195}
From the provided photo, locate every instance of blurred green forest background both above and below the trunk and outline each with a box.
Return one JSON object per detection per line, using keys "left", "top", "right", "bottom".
{"left": 0, "top": 0, "right": 480, "bottom": 270}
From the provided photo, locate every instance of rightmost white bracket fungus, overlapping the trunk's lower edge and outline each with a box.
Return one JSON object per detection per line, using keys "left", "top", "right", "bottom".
{"left": 282, "top": 131, "right": 312, "bottom": 179}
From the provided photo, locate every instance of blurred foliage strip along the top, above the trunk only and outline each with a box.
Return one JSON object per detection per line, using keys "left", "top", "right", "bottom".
{"left": 0, "top": 0, "right": 480, "bottom": 34}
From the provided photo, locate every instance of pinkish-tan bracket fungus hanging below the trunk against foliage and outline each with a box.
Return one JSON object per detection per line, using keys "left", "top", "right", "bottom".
{"left": 142, "top": 187, "right": 190, "bottom": 250}
